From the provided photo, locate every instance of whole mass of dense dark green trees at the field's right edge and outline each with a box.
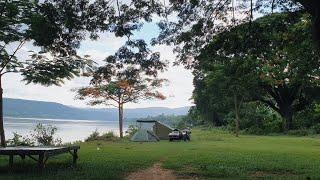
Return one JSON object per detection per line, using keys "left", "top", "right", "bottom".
{"left": 193, "top": 12, "right": 320, "bottom": 133}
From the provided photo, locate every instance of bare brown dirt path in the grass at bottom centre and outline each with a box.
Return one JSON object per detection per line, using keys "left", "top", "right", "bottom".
{"left": 126, "top": 163, "right": 192, "bottom": 180}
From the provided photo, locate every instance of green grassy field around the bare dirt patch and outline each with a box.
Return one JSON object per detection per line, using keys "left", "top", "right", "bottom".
{"left": 0, "top": 129, "right": 320, "bottom": 179}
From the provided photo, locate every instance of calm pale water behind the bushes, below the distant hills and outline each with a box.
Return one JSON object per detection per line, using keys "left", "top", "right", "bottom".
{"left": 4, "top": 117, "right": 127, "bottom": 142}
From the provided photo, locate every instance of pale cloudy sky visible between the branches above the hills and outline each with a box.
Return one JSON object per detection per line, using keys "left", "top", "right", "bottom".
{"left": 3, "top": 24, "right": 193, "bottom": 108}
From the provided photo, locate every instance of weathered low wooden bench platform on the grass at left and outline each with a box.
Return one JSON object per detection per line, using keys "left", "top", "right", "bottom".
{"left": 0, "top": 146, "right": 80, "bottom": 170}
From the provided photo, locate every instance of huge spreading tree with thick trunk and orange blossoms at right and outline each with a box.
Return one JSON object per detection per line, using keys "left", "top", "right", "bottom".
{"left": 198, "top": 12, "right": 320, "bottom": 130}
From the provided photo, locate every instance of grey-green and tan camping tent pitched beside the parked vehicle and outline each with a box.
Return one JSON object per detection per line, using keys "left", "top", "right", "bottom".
{"left": 131, "top": 120, "right": 173, "bottom": 142}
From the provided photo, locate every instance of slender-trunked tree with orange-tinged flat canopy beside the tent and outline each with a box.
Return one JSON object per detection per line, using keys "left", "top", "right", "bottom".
{"left": 77, "top": 67, "right": 166, "bottom": 138}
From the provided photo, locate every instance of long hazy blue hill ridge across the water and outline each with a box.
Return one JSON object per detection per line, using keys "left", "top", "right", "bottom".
{"left": 4, "top": 98, "right": 189, "bottom": 121}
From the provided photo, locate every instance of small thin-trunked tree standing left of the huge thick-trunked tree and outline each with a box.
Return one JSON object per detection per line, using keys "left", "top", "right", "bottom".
{"left": 194, "top": 62, "right": 256, "bottom": 137}
